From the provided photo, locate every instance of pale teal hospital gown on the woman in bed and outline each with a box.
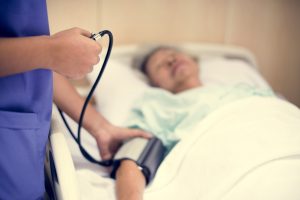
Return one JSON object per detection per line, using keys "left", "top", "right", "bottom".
{"left": 125, "top": 84, "right": 274, "bottom": 151}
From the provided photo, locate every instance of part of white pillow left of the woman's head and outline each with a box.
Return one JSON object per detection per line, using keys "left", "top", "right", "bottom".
{"left": 88, "top": 59, "right": 149, "bottom": 125}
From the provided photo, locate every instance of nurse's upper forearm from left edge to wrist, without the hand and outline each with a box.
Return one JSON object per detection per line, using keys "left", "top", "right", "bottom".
{"left": 0, "top": 36, "right": 50, "bottom": 77}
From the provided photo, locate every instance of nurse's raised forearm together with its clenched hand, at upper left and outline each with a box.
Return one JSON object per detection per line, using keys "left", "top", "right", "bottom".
{"left": 0, "top": 28, "right": 101, "bottom": 78}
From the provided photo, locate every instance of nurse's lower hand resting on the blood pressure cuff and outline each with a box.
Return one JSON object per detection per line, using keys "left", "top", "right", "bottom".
{"left": 94, "top": 125, "right": 151, "bottom": 160}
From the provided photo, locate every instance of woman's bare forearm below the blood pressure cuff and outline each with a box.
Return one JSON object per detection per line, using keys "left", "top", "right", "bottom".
{"left": 116, "top": 160, "right": 146, "bottom": 200}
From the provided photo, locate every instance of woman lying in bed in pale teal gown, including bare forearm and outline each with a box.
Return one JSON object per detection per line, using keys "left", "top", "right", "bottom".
{"left": 116, "top": 47, "right": 274, "bottom": 200}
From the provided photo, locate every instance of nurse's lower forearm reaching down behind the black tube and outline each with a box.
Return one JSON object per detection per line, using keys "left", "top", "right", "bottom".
{"left": 53, "top": 73, "right": 109, "bottom": 134}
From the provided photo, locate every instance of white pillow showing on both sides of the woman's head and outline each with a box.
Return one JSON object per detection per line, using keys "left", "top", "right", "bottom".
{"left": 88, "top": 57, "right": 270, "bottom": 126}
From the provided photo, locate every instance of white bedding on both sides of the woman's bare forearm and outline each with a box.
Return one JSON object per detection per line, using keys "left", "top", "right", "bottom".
{"left": 78, "top": 97, "right": 300, "bottom": 200}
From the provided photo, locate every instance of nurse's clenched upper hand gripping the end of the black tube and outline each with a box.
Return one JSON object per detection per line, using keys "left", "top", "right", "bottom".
{"left": 48, "top": 28, "right": 102, "bottom": 79}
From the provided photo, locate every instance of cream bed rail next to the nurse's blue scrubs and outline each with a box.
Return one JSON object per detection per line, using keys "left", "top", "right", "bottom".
{"left": 45, "top": 119, "right": 80, "bottom": 200}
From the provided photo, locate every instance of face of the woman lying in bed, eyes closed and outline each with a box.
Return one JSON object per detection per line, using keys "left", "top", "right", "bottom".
{"left": 146, "top": 48, "right": 199, "bottom": 93}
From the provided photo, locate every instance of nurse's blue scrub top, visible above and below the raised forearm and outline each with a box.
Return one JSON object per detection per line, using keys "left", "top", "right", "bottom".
{"left": 0, "top": 0, "right": 52, "bottom": 199}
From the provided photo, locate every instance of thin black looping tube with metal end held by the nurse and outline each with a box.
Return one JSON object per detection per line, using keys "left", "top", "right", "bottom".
{"left": 57, "top": 30, "right": 113, "bottom": 167}
